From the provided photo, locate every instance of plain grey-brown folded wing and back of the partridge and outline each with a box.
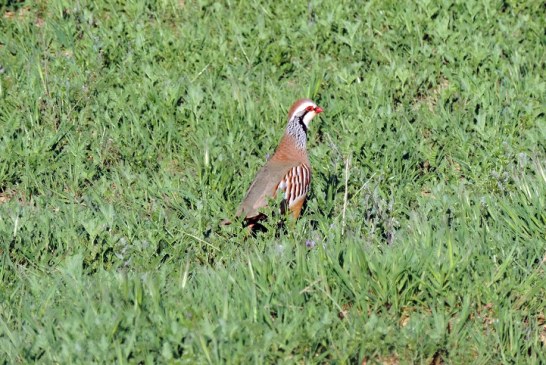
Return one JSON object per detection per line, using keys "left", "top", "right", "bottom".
{"left": 237, "top": 160, "right": 294, "bottom": 218}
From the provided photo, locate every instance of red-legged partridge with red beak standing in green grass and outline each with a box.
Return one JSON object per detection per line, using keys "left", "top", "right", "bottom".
{"left": 236, "top": 99, "right": 322, "bottom": 229}
